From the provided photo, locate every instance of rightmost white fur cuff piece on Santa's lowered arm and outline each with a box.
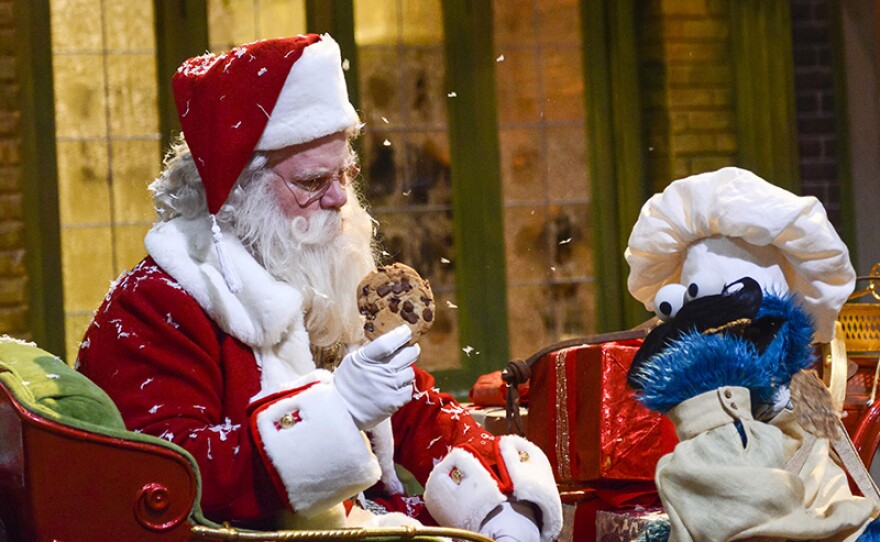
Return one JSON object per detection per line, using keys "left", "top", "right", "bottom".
{"left": 498, "top": 435, "right": 562, "bottom": 542}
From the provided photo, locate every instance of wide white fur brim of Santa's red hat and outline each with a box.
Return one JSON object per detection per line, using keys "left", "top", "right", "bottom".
{"left": 255, "top": 34, "right": 360, "bottom": 151}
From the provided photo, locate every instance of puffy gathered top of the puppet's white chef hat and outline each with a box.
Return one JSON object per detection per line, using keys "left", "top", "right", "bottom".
{"left": 626, "top": 167, "right": 855, "bottom": 342}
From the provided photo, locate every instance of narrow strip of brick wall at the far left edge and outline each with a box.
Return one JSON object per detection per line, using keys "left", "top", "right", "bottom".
{"left": 0, "top": 0, "right": 30, "bottom": 339}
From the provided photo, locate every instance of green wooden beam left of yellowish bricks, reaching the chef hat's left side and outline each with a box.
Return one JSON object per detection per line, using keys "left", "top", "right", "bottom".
{"left": 581, "top": 0, "right": 648, "bottom": 332}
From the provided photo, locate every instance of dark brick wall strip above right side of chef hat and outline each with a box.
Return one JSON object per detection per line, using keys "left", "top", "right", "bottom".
{"left": 791, "top": 0, "right": 840, "bottom": 228}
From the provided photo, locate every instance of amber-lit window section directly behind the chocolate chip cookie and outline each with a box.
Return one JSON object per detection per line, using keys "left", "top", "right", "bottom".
{"left": 354, "top": 0, "right": 461, "bottom": 369}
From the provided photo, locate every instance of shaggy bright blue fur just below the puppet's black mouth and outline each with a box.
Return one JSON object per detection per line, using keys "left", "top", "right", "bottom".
{"left": 635, "top": 331, "right": 774, "bottom": 412}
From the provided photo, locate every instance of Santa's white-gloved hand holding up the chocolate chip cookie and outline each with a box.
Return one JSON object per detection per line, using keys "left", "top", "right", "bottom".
{"left": 333, "top": 324, "right": 419, "bottom": 431}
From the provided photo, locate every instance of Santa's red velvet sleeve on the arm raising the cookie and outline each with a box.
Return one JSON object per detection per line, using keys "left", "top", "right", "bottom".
{"left": 78, "top": 258, "right": 285, "bottom": 520}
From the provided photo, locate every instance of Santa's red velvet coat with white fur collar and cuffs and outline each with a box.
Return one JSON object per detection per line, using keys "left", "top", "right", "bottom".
{"left": 78, "top": 218, "right": 562, "bottom": 540}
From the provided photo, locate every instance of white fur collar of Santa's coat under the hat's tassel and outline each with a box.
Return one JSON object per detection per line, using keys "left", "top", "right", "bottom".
{"left": 144, "top": 217, "right": 303, "bottom": 347}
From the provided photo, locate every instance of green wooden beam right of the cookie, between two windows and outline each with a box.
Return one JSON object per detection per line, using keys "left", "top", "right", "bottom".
{"left": 443, "top": 0, "right": 508, "bottom": 383}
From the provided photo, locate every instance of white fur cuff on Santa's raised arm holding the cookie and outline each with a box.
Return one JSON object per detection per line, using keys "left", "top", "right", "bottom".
{"left": 251, "top": 383, "right": 380, "bottom": 516}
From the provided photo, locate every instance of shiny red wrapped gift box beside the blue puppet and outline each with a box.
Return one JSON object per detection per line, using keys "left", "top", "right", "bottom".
{"left": 528, "top": 340, "right": 678, "bottom": 486}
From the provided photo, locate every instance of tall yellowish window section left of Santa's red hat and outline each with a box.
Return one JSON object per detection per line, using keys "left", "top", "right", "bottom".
{"left": 51, "top": 0, "right": 161, "bottom": 363}
